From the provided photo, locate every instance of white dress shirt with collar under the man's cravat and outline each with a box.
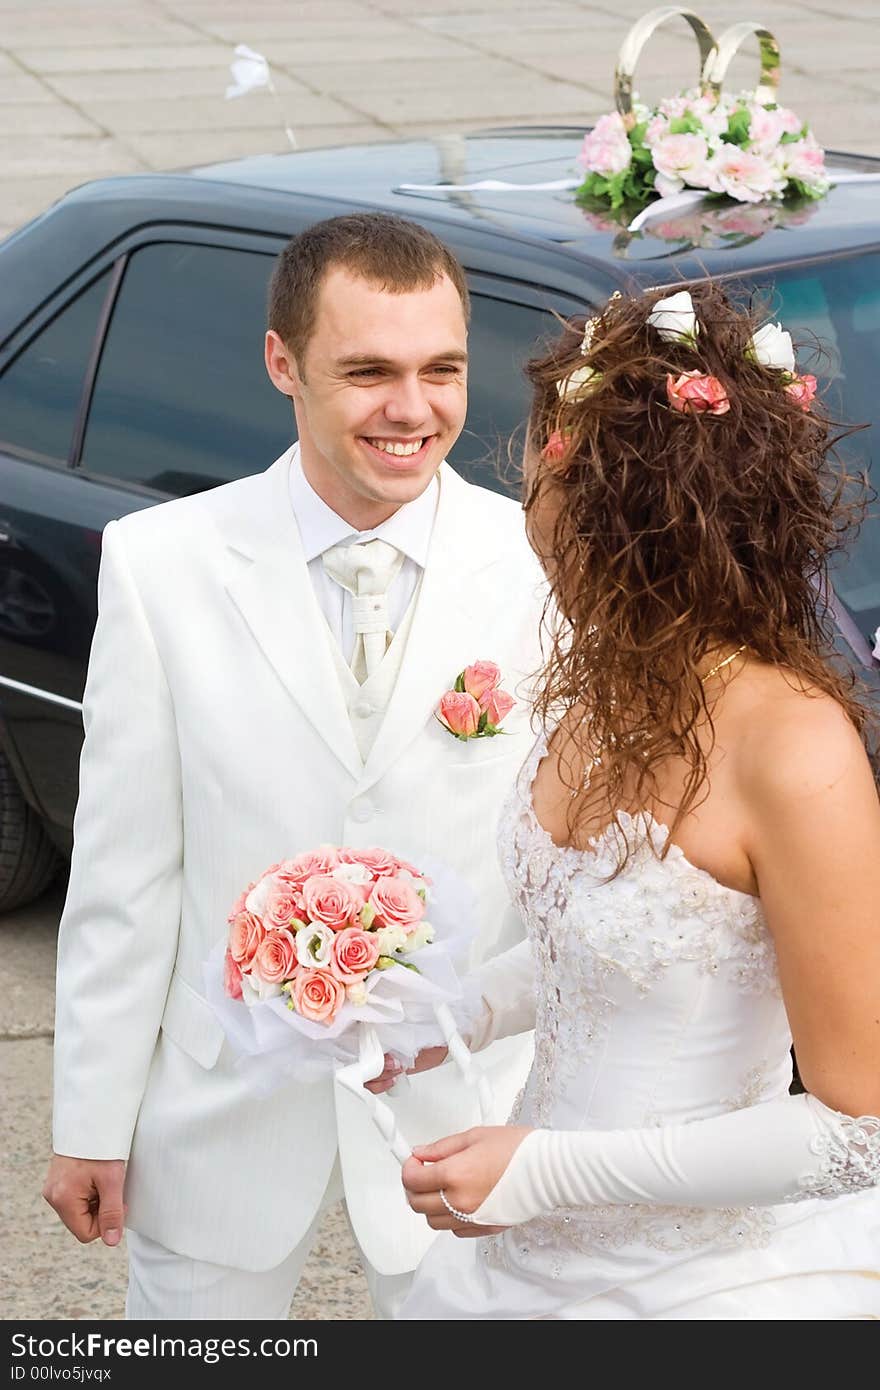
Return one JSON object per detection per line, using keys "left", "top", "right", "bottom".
{"left": 289, "top": 445, "right": 439, "bottom": 662}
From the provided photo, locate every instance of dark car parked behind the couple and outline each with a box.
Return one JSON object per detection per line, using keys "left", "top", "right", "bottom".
{"left": 0, "top": 128, "right": 880, "bottom": 910}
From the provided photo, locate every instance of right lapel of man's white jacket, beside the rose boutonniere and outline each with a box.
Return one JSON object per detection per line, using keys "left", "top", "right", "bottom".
{"left": 359, "top": 464, "right": 500, "bottom": 791}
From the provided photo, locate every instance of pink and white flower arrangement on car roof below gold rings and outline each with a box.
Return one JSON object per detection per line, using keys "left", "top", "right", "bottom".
{"left": 578, "top": 90, "right": 830, "bottom": 210}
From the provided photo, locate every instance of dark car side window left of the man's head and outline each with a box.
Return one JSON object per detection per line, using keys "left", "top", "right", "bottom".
{"left": 82, "top": 243, "right": 295, "bottom": 496}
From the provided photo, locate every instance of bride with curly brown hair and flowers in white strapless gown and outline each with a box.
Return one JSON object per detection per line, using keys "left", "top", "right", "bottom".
{"left": 403, "top": 285, "right": 880, "bottom": 1319}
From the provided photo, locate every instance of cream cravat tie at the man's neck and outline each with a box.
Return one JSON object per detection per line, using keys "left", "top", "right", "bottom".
{"left": 321, "top": 539, "right": 405, "bottom": 685}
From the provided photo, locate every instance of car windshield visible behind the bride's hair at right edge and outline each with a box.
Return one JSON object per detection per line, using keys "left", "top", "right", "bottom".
{"left": 773, "top": 254, "right": 880, "bottom": 634}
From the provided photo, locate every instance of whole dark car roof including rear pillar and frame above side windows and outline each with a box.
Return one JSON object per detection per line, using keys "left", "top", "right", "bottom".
{"left": 6, "top": 126, "right": 880, "bottom": 348}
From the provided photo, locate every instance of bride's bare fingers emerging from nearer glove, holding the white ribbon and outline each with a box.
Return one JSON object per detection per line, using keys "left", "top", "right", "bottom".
{"left": 402, "top": 1125, "right": 531, "bottom": 1236}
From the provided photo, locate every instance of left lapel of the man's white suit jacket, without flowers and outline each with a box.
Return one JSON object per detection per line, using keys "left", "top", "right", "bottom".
{"left": 221, "top": 450, "right": 363, "bottom": 777}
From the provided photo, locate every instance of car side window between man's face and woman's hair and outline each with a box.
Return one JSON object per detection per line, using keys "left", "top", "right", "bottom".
{"left": 449, "top": 295, "right": 559, "bottom": 493}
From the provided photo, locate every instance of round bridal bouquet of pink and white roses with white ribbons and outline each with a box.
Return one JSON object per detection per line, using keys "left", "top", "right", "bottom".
{"left": 204, "top": 845, "right": 489, "bottom": 1158}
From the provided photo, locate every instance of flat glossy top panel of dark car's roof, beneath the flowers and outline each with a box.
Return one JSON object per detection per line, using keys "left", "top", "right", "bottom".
{"left": 184, "top": 126, "right": 880, "bottom": 274}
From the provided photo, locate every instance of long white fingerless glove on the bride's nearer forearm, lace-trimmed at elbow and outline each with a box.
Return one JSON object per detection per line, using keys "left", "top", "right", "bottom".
{"left": 474, "top": 1095, "right": 880, "bottom": 1226}
